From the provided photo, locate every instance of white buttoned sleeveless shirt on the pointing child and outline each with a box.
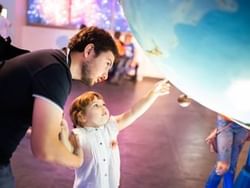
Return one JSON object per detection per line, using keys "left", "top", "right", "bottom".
{"left": 73, "top": 117, "right": 120, "bottom": 188}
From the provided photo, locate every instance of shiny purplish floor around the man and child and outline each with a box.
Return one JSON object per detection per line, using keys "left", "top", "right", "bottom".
{"left": 12, "top": 79, "right": 249, "bottom": 188}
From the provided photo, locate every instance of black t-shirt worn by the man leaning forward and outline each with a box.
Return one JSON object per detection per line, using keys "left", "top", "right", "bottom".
{"left": 0, "top": 50, "right": 71, "bottom": 164}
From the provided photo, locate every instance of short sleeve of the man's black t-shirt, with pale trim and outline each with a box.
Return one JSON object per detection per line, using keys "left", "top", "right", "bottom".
{"left": 33, "top": 64, "right": 71, "bottom": 109}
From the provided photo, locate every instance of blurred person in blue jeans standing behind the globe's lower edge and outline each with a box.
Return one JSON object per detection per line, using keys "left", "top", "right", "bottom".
{"left": 205, "top": 114, "right": 249, "bottom": 188}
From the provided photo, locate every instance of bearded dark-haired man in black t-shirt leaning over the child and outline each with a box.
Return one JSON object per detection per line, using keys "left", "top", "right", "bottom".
{"left": 0, "top": 27, "right": 117, "bottom": 188}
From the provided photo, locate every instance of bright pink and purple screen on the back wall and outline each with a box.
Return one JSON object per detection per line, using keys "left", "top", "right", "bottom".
{"left": 27, "top": 0, "right": 130, "bottom": 31}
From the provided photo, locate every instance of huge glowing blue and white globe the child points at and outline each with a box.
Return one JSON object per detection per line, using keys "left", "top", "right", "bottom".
{"left": 120, "top": 0, "right": 250, "bottom": 128}
